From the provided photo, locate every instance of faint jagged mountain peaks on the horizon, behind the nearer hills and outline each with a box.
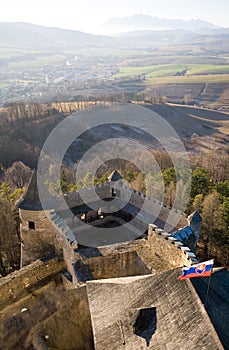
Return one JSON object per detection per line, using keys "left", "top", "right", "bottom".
{"left": 102, "top": 14, "right": 220, "bottom": 33}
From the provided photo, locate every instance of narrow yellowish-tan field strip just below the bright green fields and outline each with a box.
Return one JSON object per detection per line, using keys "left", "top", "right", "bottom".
{"left": 144, "top": 74, "right": 229, "bottom": 85}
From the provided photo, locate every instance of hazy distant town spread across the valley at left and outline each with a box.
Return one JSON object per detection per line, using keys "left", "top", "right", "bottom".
{"left": 0, "top": 56, "right": 118, "bottom": 104}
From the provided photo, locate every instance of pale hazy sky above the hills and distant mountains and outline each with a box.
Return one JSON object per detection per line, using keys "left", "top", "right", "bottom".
{"left": 0, "top": 0, "right": 229, "bottom": 35}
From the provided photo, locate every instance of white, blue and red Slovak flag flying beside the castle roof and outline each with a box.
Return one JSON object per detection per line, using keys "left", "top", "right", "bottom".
{"left": 178, "top": 259, "right": 214, "bottom": 280}
